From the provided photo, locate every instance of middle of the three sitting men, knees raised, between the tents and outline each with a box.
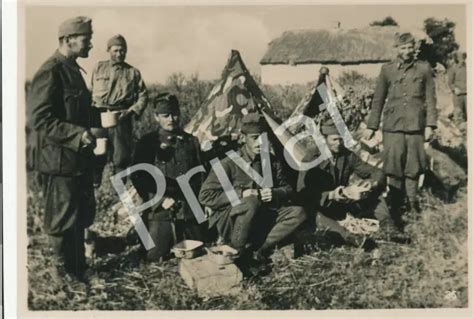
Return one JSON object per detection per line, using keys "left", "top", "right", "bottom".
{"left": 199, "top": 113, "right": 306, "bottom": 268}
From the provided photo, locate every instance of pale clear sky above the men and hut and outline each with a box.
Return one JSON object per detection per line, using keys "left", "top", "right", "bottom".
{"left": 25, "top": 5, "right": 466, "bottom": 83}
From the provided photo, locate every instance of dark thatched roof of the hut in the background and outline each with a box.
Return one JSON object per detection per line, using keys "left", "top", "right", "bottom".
{"left": 260, "top": 26, "right": 426, "bottom": 65}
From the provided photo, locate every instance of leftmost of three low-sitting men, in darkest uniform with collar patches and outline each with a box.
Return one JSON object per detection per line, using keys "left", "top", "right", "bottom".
{"left": 132, "top": 93, "right": 206, "bottom": 261}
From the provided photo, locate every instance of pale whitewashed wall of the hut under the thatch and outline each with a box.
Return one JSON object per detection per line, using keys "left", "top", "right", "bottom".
{"left": 261, "top": 63, "right": 383, "bottom": 85}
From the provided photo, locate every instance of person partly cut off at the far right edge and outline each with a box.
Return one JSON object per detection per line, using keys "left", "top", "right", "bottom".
{"left": 448, "top": 52, "right": 467, "bottom": 123}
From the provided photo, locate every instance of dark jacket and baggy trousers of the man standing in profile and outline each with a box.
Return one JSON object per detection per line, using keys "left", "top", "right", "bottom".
{"left": 28, "top": 52, "right": 99, "bottom": 234}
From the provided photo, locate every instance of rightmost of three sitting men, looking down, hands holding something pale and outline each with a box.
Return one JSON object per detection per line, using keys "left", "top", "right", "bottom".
{"left": 298, "top": 120, "right": 404, "bottom": 249}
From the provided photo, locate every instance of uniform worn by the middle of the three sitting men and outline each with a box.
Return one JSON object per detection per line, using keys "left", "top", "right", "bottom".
{"left": 199, "top": 117, "right": 306, "bottom": 254}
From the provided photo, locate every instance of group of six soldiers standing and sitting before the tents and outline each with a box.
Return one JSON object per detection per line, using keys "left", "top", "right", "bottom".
{"left": 28, "top": 17, "right": 460, "bottom": 288}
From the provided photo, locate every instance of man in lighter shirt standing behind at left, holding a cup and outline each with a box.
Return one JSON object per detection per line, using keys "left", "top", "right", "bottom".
{"left": 92, "top": 34, "right": 148, "bottom": 187}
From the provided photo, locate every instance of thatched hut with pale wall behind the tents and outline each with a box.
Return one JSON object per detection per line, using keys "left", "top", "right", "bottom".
{"left": 260, "top": 26, "right": 429, "bottom": 83}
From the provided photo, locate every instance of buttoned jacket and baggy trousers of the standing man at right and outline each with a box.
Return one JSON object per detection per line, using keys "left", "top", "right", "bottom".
{"left": 367, "top": 60, "right": 437, "bottom": 179}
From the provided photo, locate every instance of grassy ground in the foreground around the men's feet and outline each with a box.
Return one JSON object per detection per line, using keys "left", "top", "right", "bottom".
{"left": 27, "top": 74, "right": 468, "bottom": 310}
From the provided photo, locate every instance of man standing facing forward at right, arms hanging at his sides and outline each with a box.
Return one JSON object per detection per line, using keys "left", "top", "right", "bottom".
{"left": 366, "top": 33, "right": 437, "bottom": 216}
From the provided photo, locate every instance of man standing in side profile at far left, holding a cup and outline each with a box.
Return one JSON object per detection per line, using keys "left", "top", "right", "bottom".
{"left": 28, "top": 17, "right": 98, "bottom": 280}
